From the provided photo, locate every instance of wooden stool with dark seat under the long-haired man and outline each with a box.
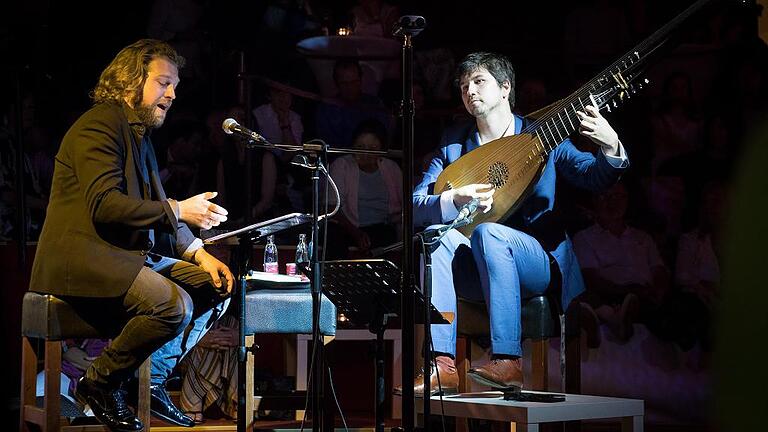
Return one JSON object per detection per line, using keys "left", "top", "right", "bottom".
{"left": 19, "top": 292, "right": 150, "bottom": 432}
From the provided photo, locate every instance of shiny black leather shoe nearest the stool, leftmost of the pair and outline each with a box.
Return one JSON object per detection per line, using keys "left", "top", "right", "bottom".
{"left": 75, "top": 377, "right": 144, "bottom": 432}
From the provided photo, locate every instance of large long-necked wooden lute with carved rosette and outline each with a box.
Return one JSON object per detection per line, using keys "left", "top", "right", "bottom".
{"left": 434, "top": 0, "right": 711, "bottom": 237}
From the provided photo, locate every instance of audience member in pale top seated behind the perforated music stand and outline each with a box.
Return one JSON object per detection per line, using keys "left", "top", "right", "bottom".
{"left": 330, "top": 120, "right": 403, "bottom": 255}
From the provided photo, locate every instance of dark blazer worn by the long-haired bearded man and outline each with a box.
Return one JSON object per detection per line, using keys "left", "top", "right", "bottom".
{"left": 30, "top": 103, "right": 195, "bottom": 297}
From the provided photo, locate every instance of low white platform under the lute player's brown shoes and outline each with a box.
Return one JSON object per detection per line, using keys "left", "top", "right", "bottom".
{"left": 416, "top": 391, "right": 645, "bottom": 432}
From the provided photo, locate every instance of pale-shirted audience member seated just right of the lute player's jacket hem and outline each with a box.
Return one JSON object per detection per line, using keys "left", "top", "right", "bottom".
{"left": 573, "top": 183, "right": 669, "bottom": 346}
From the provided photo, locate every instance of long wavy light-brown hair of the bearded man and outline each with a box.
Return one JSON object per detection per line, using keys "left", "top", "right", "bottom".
{"left": 90, "top": 39, "right": 185, "bottom": 106}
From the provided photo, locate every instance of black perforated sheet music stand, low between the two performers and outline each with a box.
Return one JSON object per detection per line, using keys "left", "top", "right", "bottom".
{"left": 314, "top": 259, "right": 449, "bottom": 432}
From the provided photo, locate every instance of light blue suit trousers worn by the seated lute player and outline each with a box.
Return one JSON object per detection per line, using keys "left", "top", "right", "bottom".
{"left": 430, "top": 223, "right": 550, "bottom": 356}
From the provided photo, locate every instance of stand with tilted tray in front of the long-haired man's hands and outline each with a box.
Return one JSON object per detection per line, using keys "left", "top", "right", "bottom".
{"left": 201, "top": 213, "right": 313, "bottom": 432}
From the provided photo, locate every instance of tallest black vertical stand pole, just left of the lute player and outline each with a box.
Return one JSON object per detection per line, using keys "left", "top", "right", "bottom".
{"left": 393, "top": 15, "right": 424, "bottom": 431}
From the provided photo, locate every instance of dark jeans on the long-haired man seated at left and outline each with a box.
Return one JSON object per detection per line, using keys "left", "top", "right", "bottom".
{"left": 66, "top": 251, "right": 229, "bottom": 385}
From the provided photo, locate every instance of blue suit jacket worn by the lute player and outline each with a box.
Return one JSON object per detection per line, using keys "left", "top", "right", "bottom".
{"left": 413, "top": 116, "right": 628, "bottom": 307}
